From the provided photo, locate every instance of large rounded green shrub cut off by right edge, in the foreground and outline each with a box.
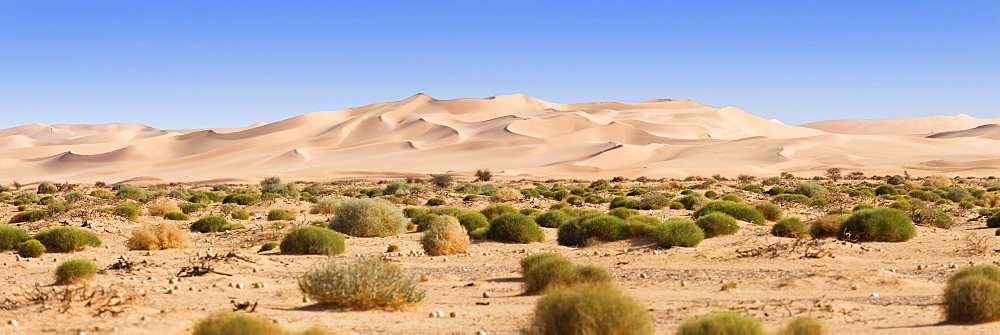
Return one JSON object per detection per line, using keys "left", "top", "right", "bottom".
{"left": 944, "top": 274, "right": 1000, "bottom": 323}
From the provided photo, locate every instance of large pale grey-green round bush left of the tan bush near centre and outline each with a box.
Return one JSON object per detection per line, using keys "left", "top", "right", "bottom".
{"left": 330, "top": 199, "right": 409, "bottom": 237}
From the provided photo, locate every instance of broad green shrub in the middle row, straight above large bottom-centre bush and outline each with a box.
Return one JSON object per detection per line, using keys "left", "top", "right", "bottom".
{"left": 558, "top": 214, "right": 625, "bottom": 246}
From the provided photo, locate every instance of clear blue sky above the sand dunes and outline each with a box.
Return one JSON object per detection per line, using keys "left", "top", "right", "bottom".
{"left": 0, "top": 0, "right": 1000, "bottom": 129}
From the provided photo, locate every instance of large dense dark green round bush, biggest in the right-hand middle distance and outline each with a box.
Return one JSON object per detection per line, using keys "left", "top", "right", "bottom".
{"left": 837, "top": 207, "right": 917, "bottom": 242}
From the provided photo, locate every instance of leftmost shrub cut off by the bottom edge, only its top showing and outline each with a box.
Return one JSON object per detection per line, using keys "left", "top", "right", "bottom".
{"left": 192, "top": 312, "right": 288, "bottom": 335}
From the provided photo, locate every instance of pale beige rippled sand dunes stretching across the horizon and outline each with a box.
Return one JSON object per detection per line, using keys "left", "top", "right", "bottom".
{"left": 0, "top": 94, "right": 1000, "bottom": 182}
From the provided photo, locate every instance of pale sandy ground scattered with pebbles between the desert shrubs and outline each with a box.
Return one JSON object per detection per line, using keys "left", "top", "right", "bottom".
{"left": 0, "top": 181, "right": 1000, "bottom": 334}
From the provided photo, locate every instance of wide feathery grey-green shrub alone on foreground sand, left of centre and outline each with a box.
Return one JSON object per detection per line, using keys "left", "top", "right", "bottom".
{"left": 299, "top": 256, "right": 425, "bottom": 310}
